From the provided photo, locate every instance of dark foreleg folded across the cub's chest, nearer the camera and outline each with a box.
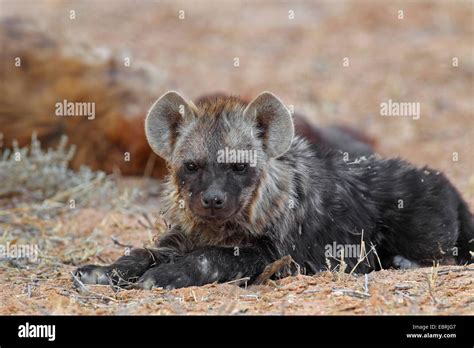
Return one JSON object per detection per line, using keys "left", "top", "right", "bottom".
{"left": 138, "top": 247, "right": 271, "bottom": 289}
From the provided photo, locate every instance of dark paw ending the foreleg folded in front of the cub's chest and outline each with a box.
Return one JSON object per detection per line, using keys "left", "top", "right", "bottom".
{"left": 137, "top": 264, "right": 194, "bottom": 290}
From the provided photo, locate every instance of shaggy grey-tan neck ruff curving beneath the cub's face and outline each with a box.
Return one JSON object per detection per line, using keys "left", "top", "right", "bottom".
{"left": 162, "top": 137, "right": 318, "bottom": 246}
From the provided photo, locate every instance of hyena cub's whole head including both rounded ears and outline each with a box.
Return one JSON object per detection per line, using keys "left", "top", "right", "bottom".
{"left": 145, "top": 91, "right": 294, "bottom": 225}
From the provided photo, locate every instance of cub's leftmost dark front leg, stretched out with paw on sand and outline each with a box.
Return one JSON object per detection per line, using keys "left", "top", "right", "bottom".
{"left": 74, "top": 249, "right": 155, "bottom": 285}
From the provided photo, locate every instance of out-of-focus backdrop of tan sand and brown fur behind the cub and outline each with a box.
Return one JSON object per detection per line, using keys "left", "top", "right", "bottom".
{"left": 0, "top": 0, "right": 474, "bottom": 207}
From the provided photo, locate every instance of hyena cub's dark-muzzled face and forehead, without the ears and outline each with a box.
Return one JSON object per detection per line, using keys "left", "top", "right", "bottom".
{"left": 170, "top": 114, "right": 263, "bottom": 222}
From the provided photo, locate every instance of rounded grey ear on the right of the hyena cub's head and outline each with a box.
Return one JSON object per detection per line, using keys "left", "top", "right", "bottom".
{"left": 244, "top": 92, "right": 295, "bottom": 157}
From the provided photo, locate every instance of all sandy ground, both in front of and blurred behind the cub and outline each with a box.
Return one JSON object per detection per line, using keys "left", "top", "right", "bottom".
{"left": 0, "top": 0, "right": 474, "bottom": 314}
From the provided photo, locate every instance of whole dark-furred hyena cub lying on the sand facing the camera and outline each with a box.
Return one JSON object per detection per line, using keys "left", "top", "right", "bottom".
{"left": 76, "top": 92, "right": 474, "bottom": 289}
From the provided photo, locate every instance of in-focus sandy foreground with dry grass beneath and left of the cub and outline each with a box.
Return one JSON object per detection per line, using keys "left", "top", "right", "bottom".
{"left": 0, "top": 189, "right": 474, "bottom": 315}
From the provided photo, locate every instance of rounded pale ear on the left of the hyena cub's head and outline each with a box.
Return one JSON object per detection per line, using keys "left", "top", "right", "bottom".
{"left": 145, "top": 91, "right": 196, "bottom": 160}
